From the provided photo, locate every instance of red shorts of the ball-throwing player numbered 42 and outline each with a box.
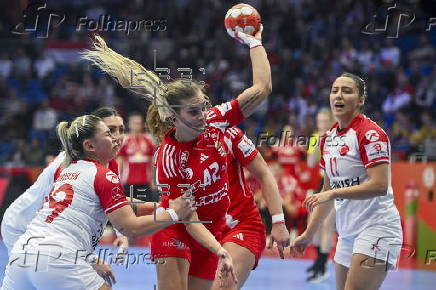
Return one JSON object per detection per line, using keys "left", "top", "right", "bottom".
{"left": 151, "top": 229, "right": 218, "bottom": 280}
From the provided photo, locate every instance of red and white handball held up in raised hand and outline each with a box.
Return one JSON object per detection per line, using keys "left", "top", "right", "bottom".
{"left": 224, "top": 3, "right": 260, "bottom": 35}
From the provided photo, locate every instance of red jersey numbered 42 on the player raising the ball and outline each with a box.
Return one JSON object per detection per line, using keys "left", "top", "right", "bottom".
{"left": 155, "top": 100, "right": 243, "bottom": 235}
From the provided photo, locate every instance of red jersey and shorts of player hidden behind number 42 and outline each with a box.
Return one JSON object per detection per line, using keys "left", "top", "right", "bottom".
{"left": 221, "top": 127, "right": 266, "bottom": 269}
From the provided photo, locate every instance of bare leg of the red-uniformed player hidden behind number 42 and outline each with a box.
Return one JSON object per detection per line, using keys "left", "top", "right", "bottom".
{"left": 212, "top": 242, "right": 256, "bottom": 290}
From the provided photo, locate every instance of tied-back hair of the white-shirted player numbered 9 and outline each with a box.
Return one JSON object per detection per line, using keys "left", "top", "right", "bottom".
{"left": 56, "top": 115, "right": 102, "bottom": 166}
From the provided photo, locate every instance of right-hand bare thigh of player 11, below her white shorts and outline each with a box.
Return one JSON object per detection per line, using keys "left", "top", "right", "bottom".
{"left": 345, "top": 254, "right": 387, "bottom": 290}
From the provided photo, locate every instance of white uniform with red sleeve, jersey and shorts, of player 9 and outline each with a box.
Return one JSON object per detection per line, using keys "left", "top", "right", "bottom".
{"left": 3, "top": 160, "right": 129, "bottom": 289}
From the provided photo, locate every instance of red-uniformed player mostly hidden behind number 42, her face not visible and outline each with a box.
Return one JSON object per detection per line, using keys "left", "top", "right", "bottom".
{"left": 212, "top": 127, "right": 289, "bottom": 290}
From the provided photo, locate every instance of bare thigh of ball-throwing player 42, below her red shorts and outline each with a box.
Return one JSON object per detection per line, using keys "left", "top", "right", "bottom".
{"left": 156, "top": 257, "right": 189, "bottom": 290}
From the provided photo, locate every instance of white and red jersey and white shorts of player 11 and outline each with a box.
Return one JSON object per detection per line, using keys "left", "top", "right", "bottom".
{"left": 320, "top": 114, "right": 402, "bottom": 267}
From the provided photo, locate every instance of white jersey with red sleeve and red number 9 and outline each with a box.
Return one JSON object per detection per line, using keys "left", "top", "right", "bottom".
{"left": 12, "top": 160, "right": 129, "bottom": 257}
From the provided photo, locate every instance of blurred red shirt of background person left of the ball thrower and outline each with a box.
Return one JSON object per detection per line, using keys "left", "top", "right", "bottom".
{"left": 118, "top": 134, "right": 154, "bottom": 185}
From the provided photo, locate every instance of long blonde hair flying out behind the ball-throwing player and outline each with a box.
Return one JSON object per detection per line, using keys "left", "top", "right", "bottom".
{"left": 82, "top": 35, "right": 208, "bottom": 139}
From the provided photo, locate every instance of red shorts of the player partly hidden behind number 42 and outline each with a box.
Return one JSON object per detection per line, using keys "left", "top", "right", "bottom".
{"left": 220, "top": 214, "right": 266, "bottom": 270}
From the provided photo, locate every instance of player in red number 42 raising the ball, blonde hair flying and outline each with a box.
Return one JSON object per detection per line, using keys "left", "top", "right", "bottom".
{"left": 84, "top": 22, "right": 271, "bottom": 290}
